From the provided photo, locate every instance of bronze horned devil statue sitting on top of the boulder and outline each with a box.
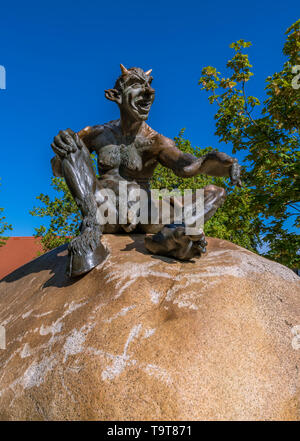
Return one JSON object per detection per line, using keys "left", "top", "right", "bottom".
{"left": 51, "top": 65, "right": 240, "bottom": 277}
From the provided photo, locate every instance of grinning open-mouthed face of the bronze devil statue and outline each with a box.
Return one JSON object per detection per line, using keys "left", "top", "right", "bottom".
{"left": 120, "top": 74, "right": 155, "bottom": 121}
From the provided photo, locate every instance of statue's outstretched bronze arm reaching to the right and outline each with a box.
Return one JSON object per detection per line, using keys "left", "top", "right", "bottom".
{"left": 158, "top": 135, "right": 237, "bottom": 178}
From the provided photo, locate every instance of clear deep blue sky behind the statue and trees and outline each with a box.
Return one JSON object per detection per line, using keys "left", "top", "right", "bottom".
{"left": 0, "top": 0, "right": 300, "bottom": 236}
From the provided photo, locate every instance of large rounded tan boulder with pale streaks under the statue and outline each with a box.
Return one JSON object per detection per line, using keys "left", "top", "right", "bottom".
{"left": 0, "top": 235, "right": 300, "bottom": 420}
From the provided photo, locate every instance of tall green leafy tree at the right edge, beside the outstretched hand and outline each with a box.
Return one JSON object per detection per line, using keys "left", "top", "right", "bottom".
{"left": 199, "top": 20, "right": 300, "bottom": 267}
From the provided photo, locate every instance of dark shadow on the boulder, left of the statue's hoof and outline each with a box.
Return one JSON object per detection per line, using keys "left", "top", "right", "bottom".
{"left": 1, "top": 244, "right": 83, "bottom": 289}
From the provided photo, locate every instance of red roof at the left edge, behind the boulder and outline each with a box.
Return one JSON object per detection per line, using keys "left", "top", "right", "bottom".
{"left": 0, "top": 237, "right": 43, "bottom": 280}
